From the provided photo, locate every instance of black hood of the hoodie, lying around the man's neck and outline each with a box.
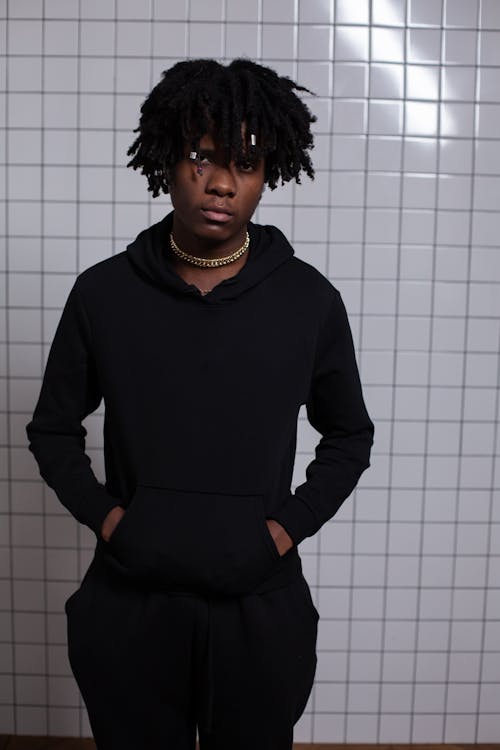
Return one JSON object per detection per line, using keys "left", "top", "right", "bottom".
{"left": 126, "top": 211, "right": 294, "bottom": 305}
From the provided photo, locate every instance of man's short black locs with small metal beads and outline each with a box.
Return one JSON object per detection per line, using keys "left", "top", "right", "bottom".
{"left": 127, "top": 58, "right": 317, "bottom": 198}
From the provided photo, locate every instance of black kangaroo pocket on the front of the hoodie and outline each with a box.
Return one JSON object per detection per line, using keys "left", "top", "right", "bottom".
{"left": 108, "top": 482, "right": 280, "bottom": 595}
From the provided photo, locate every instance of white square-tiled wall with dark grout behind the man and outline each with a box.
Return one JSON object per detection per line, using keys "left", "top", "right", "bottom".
{"left": 0, "top": 0, "right": 500, "bottom": 743}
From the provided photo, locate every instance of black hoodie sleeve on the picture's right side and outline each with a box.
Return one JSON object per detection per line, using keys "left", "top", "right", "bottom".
{"left": 270, "top": 290, "right": 374, "bottom": 545}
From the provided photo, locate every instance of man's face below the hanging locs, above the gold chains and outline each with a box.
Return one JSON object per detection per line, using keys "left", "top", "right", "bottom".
{"left": 170, "top": 129, "right": 264, "bottom": 245}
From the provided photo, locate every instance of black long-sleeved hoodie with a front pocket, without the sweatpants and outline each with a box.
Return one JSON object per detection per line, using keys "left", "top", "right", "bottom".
{"left": 26, "top": 212, "right": 374, "bottom": 595}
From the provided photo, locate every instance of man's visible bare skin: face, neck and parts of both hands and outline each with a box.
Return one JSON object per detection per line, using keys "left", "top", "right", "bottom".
{"left": 101, "top": 125, "right": 293, "bottom": 556}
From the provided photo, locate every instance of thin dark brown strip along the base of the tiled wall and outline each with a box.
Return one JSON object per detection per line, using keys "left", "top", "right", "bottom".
{"left": 0, "top": 734, "right": 500, "bottom": 750}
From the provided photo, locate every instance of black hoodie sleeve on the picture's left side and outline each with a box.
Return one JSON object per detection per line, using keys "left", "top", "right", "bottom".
{"left": 26, "top": 279, "right": 119, "bottom": 537}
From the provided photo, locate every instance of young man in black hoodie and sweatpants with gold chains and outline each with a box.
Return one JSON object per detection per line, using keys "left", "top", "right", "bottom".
{"left": 26, "top": 60, "right": 373, "bottom": 750}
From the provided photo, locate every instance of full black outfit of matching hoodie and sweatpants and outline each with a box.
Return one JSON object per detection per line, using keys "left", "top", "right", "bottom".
{"left": 26, "top": 213, "right": 373, "bottom": 750}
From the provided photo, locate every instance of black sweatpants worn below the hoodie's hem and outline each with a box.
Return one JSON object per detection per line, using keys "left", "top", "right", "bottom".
{"left": 66, "top": 559, "right": 319, "bottom": 750}
